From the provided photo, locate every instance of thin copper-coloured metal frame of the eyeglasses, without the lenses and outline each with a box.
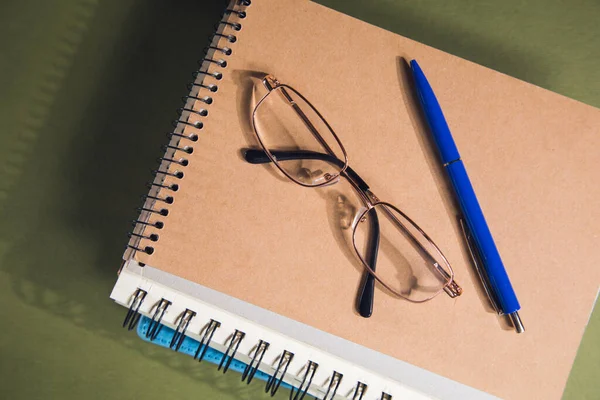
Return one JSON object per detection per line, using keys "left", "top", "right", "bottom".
{"left": 244, "top": 75, "right": 462, "bottom": 303}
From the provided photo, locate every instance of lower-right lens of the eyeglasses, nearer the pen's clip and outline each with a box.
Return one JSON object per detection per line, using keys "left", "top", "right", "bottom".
{"left": 353, "top": 203, "right": 453, "bottom": 302}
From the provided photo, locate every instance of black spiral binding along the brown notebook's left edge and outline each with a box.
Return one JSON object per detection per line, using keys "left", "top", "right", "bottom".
{"left": 127, "top": 0, "right": 251, "bottom": 256}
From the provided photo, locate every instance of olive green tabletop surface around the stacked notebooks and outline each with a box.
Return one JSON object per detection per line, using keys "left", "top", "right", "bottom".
{"left": 0, "top": 0, "right": 600, "bottom": 400}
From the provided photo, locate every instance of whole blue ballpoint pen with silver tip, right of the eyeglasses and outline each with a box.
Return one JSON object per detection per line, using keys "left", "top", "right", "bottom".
{"left": 410, "top": 60, "right": 525, "bottom": 333}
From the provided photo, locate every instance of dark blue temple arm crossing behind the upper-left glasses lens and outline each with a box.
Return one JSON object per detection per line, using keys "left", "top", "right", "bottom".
{"left": 243, "top": 149, "right": 369, "bottom": 192}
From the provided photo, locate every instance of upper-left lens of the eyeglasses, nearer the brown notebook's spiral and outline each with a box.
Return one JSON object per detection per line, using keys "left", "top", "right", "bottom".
{"left": 253, "top": 85, "right": 346, "bottom": 186}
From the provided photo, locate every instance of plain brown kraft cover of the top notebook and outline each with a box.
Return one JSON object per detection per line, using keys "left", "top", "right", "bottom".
{"left": 129, "top": 0, "right": 600, "bottom": 399}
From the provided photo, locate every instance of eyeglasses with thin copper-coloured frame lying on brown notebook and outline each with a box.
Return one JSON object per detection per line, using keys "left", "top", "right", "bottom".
{"left": 245, "top": 75, "right": 462, "bottom": 316}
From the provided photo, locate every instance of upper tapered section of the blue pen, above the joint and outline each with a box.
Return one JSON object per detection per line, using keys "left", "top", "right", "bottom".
{"left": 410, "top": 60, "right": 460, "bottom": 164}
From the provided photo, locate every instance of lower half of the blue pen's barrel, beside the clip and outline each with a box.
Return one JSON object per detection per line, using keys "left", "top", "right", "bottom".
{"left": 446, "top": 160, "right": 521, "bottom": 314}
